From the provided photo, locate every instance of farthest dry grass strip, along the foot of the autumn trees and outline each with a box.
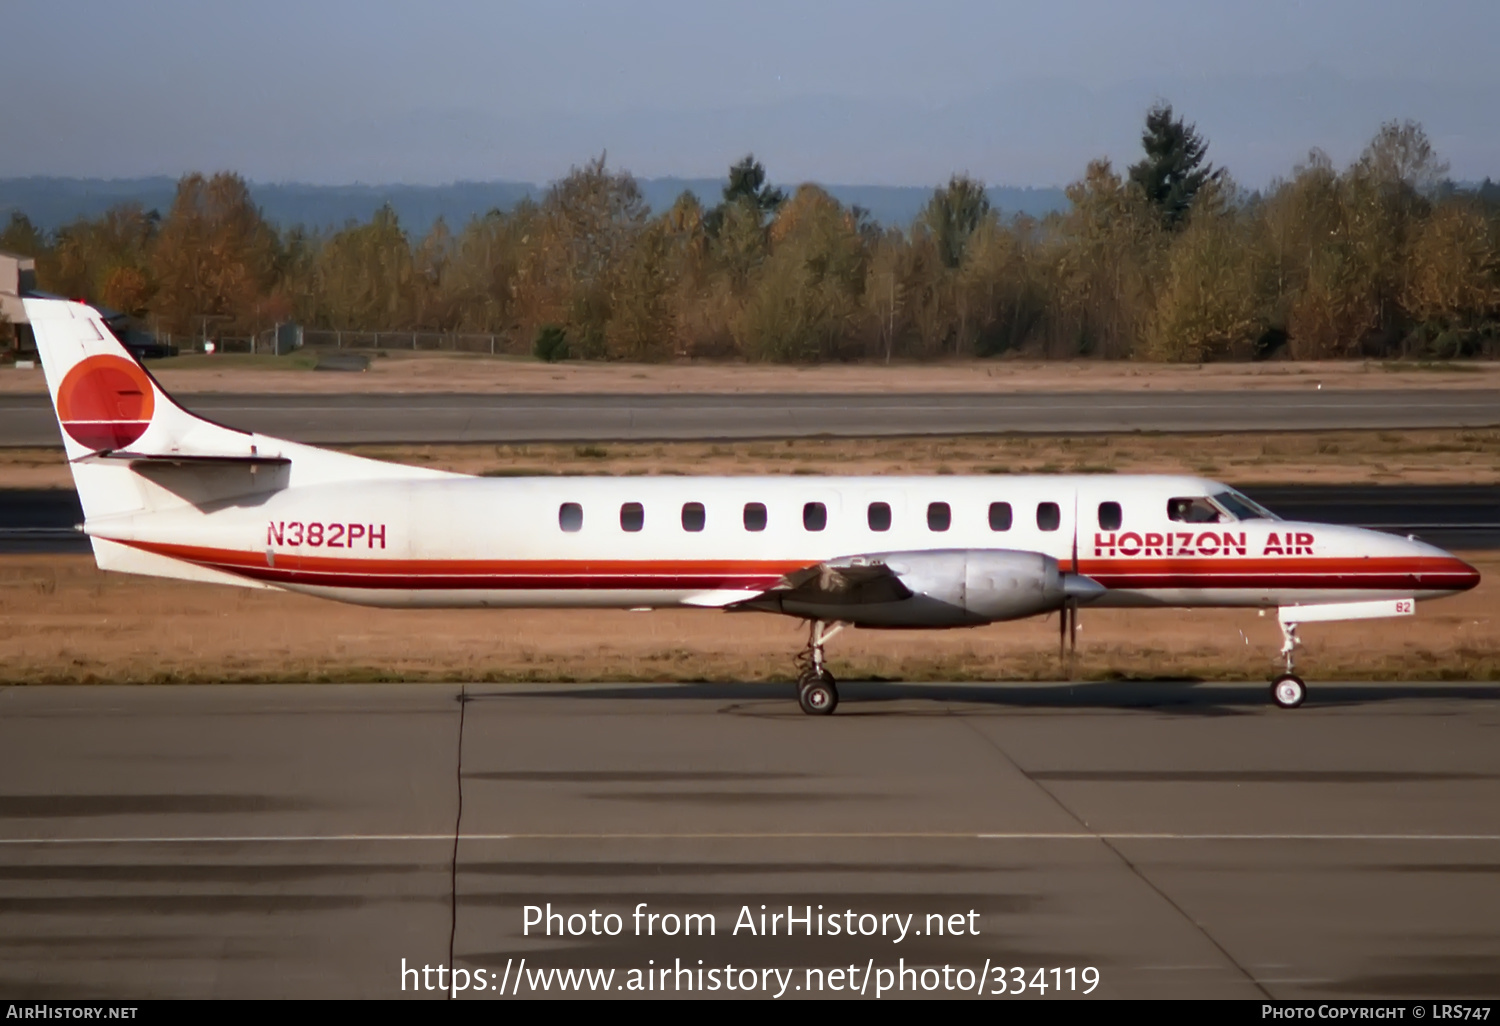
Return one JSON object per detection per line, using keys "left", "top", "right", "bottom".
{"left": 0, "top": 351, "right": 1500, "bottom": 395}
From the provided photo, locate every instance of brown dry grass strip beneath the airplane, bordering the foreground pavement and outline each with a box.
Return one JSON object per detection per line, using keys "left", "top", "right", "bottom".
{"left": 0, "top": 554, "right": 1500, "bottom": 684}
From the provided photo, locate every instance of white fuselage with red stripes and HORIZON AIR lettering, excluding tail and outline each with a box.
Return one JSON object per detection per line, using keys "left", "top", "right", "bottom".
{"left": 89, "top": 474, "right": 1478, "bottom": 618}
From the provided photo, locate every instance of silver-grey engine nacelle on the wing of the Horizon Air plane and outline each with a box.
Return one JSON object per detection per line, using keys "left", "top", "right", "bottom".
{"left": 774, "top": 549, "right": 1104, "bottom": 627}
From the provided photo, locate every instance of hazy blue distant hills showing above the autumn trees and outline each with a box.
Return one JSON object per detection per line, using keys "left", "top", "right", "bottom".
{"left": 0, "top": 176, "right": 1068, "bottom": 234}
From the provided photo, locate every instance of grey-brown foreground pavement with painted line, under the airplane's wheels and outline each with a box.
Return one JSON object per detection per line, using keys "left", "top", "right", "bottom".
{"left": 0, "top": 683, "right": 1500, "bottom": 999}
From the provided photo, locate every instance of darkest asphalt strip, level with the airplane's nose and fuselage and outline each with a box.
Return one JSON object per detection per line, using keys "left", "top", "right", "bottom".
{"left": 0, "top": 485, "right": 1500, "bottom": 554}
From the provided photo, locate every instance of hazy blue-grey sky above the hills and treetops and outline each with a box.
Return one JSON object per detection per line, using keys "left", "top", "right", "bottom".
{"left": 11, "top": 0, "right": 1500, "bottom": 186}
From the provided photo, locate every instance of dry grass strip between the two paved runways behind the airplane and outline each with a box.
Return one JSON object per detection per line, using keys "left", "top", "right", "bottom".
{"left": 0, "top": 428, "right": 1500, "bottom": 489}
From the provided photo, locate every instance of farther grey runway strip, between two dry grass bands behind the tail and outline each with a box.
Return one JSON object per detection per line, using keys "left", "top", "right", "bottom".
{"left": 0, "top": 386, "right": 1500, "bottom": 446}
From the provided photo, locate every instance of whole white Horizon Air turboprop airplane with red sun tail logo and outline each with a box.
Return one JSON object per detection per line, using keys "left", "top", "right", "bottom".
{"left": 23, "top": 299, "right": 1479, "bottom": 716}
